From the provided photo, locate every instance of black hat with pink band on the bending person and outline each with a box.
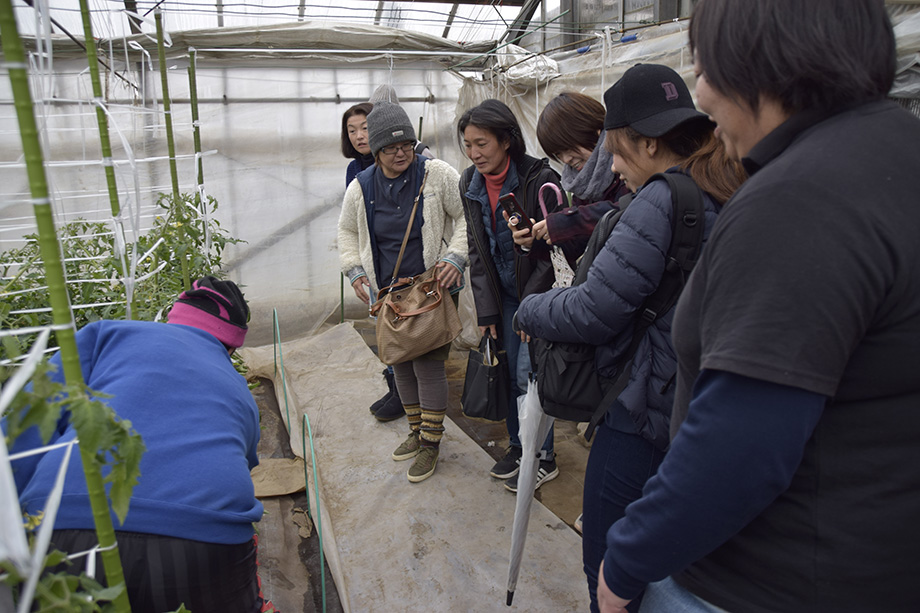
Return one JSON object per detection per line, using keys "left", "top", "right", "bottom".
{"left": 167, "top": 277, "right": 249, "bottom": 348}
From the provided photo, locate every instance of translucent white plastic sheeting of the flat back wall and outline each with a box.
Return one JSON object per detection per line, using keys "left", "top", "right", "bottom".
{"left": 0, "top": 39, "right": 474, "bottom": 344}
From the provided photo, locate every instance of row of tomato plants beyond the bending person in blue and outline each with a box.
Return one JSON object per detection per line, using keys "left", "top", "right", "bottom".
{"left": 0, "top": 193, "right": 243, "bottom": 360}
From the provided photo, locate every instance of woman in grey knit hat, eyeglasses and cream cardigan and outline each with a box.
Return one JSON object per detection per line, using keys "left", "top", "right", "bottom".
{"left": 338, "top": 101, "right": 467, "bottom": 483}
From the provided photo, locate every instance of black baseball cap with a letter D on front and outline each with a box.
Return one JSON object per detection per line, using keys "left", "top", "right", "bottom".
{"left": 604, "top": 64, "right": 706, "bottom": 138}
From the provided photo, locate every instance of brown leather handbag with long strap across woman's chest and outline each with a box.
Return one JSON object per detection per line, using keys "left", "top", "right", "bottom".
{"left": 370, "top": 170, "right": 463, "bottom": 364}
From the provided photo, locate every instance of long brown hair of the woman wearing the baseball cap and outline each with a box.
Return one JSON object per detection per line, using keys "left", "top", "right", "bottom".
{"left": 607, "top": 118, "right": 747, "bottom": 204}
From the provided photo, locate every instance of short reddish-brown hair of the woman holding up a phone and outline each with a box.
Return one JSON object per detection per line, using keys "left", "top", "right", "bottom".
{"left": 537, "top": 92, "right": 605, "bottom": 160}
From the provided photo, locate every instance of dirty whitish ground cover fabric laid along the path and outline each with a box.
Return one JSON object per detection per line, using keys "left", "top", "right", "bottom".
{"left": 242, "top": 323, "right": 588, "bottom": 611}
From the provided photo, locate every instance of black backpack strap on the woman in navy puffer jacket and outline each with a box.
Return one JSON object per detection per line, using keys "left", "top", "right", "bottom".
{"left": 585, "top": 173, "right": 706, "bottom": 440}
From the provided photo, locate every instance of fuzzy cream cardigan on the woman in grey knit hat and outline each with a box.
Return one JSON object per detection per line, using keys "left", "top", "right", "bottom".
{"left": 338, "top": 155, "right": 468, "bottom": 294}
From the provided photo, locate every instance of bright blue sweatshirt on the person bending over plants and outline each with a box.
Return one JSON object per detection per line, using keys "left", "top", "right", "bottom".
{"left": 10, "top": 321, "right": 262, "bottom": 545}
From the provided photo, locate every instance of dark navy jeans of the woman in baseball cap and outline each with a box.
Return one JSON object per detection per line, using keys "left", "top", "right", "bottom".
{"left": 581, "top": 424, "right": 664, "bottom": 613}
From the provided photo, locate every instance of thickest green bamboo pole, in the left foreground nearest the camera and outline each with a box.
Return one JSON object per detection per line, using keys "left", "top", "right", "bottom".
{"left": 0, "top": 0, "right": 131, "bottom": 612}
